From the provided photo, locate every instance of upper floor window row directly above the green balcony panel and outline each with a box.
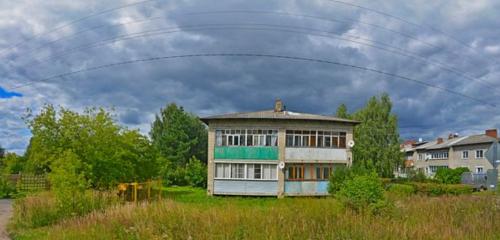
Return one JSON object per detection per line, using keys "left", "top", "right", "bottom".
{"left": 215, "top": 129, "right": 278, "bottom": 146}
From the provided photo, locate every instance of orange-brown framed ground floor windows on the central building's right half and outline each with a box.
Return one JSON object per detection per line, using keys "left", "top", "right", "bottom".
{"left": 285, "top": 163, "right": 334, "bottom": 181}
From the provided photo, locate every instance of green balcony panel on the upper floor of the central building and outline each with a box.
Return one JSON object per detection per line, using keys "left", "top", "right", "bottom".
{"left": 214, "top": 147, "right": 278, "bottom": 160}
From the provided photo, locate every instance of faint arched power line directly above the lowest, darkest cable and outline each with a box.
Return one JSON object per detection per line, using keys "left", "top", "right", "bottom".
{"left": 21, "top": 23, "right": 493, "bottom": 87}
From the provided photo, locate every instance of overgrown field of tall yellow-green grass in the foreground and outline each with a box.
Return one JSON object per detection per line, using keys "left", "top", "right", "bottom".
{"left": 10, "top": 188, "right": 500, "bottom": 239}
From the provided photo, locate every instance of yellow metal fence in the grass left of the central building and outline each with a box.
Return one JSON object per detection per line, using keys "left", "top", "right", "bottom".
{"left": 118, "top": 180, "right": 162, "bottom": 203}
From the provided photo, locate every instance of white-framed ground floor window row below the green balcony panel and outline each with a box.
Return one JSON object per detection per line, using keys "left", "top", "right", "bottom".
{"left": 215, "top": 163, "right": 278, "bottom": 180}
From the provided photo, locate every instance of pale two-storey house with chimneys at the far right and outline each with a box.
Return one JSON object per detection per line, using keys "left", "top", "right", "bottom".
{"left": 401, "top": 129, "right": 498, "bottom": 176}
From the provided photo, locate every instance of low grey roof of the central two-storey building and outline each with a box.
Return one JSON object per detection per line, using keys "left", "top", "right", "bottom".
{"left": 200, "top": 110, "right": 360, "bottom": 124}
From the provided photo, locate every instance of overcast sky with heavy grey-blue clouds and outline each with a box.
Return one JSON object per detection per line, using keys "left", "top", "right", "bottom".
{"left": 0, "top": 0, "right": 500, "bottom": 153}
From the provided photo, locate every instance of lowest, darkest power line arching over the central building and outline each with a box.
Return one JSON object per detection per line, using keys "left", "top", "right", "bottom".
{"left": 8, "top": 53, "right": 496, "bottom": 108}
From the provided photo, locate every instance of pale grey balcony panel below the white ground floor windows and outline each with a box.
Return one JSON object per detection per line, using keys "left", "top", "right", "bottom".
{"left": 214, "top": 179, "right": 278, "bottom": 196}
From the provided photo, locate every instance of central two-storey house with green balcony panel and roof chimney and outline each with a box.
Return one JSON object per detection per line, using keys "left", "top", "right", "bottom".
{"left": 201, "top": 100, "right": 358, "bottom": 197}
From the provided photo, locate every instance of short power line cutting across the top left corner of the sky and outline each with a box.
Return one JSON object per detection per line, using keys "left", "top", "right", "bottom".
{"left": 0, "top": 0, "right": 158, "bottom": 54}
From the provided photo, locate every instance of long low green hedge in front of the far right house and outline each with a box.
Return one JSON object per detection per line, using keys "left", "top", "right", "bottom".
{"left": 409, "top": 183, "right": 473, "bottom": 196}
